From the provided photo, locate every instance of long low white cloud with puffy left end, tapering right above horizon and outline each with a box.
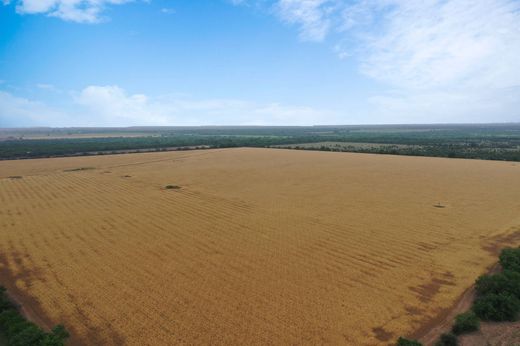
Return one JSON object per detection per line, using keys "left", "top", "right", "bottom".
{"left": 75, "top": 86, "right": 334, "bottom": 125}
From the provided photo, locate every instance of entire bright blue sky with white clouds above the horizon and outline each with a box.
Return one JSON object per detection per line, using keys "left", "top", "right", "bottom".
{"left": 0, "top": 0, "right": 520, "bottom": 128}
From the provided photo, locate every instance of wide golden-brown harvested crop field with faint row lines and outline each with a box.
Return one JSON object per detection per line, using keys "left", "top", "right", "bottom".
{"left": 0, "top": 149, "right": 520, "bottom": 345}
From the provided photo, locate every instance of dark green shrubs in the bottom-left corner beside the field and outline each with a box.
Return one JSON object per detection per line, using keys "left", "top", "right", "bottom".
{"left": 0, "top": 287, "right": 69, "bottom": 346}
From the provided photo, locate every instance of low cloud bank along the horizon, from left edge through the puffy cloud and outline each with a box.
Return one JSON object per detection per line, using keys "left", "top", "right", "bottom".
{"left": 0, "top": 85, "right": 338, "bottom": 127}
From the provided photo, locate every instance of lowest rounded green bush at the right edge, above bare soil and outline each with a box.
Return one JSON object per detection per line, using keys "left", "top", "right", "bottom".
{"left": 473, "top": 293, "right": 520, "bottom": 321}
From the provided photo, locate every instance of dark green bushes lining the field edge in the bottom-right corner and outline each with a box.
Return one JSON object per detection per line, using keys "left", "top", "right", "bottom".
{"left": 397, "top": 248, "right": 520, "bottom": 346}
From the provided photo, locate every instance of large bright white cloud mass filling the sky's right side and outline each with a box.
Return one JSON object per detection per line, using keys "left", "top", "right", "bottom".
{"left": 235, "top": 0, "right": 520, "bottom": 122}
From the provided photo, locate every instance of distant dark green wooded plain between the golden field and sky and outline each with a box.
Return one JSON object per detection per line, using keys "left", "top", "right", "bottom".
{"left": 0, "top": 124, "right": 520, "bottom": 161}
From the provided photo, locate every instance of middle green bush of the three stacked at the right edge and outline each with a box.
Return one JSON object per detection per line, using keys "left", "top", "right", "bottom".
{"left": 475, "top": 270, "right": 520, "bottom": 299}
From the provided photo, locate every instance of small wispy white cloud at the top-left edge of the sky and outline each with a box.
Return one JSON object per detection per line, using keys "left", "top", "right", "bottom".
{"left": 10, "top": 0, "right": 133, "bottom": 23}
